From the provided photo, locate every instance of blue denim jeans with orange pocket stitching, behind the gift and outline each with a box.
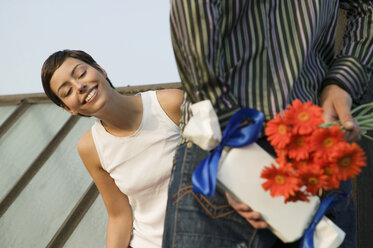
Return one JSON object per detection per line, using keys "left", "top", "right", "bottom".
{"left": 162, "top": 142, "right": 355, "bottom": 248}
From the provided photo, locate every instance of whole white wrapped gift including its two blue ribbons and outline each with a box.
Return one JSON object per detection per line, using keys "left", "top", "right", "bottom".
{"left": 183, "top": 100, "right": 345, "bottom": 248}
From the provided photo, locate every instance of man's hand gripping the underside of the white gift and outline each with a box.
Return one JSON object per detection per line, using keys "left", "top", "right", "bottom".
{"left": 225, "top": 193, "right": 268, "bottom": 229}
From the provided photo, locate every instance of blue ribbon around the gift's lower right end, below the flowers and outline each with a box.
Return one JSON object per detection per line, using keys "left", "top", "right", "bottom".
{"left": 299, "top": 194, "right": 343, "bottom": 248}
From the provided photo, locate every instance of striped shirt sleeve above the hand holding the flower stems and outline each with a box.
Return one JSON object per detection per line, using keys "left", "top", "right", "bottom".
{"left": 323, "top": 0, "right": 373, "bottom": 102}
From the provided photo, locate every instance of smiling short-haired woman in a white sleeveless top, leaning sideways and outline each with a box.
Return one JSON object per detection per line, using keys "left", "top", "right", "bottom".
{"left": 42, "top": 50, "right": 183, "bottom": 248}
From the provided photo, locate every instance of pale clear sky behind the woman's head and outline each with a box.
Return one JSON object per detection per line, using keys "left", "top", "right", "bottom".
{"left": 0, "top": 0, "right": 180, "bottom": 95}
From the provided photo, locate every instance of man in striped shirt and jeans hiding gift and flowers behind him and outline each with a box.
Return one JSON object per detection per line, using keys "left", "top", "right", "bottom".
{"left": 163, "top": 0, "right": 373, "bottom": 248}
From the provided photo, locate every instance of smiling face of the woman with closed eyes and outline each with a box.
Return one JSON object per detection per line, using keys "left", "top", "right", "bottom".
{"left": 50, "top": 58, "right": 110, "bottom": 116}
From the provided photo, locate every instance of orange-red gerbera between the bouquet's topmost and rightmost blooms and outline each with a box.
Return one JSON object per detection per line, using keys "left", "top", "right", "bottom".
{"left": 311, "top": 125, "right": 344, "bottom": 159}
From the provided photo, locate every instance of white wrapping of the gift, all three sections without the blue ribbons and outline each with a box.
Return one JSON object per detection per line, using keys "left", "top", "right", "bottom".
{"left": 183, "top": 100, "right": 345, "bottom": 248}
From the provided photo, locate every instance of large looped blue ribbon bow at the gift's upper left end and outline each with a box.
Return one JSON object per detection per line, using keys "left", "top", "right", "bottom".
{"left": 192, "top": 108, "right": 264, "bottom": 196}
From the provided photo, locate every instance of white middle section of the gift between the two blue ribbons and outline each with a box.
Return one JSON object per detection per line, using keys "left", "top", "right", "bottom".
{"left": 217, "top": 143, "right": 320, "bottom": 243}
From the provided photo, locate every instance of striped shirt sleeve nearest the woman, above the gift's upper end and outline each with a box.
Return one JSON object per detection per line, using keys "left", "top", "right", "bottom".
{"left": 170, "top": 0, "right": 239, "bottom": 125}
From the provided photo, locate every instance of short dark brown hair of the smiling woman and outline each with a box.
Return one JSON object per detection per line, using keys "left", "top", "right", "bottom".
{"left": 41, "top": 49, "right": 114, "bottom": 107}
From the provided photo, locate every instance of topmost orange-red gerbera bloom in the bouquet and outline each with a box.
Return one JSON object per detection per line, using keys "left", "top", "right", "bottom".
{"left": 285, "top": 99, "right": 323, "bottom": 135}
